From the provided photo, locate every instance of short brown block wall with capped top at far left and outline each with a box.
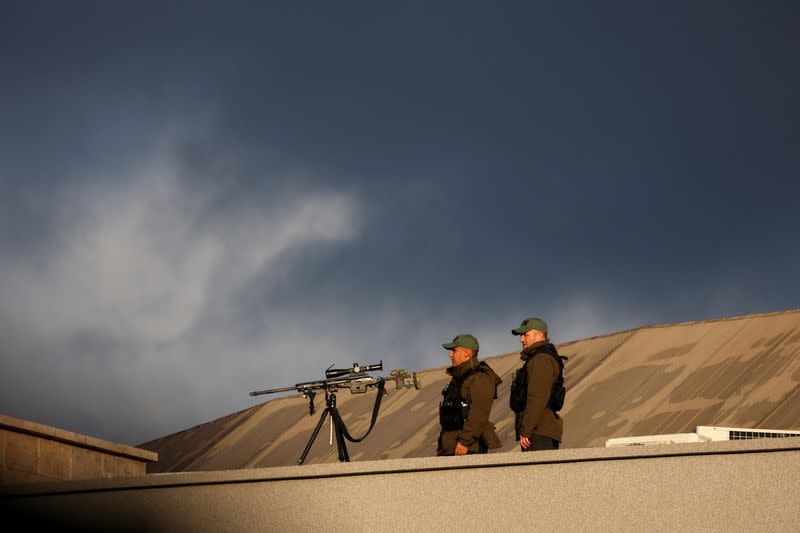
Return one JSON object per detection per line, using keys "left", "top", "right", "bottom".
{"left": 0, "top": 415, "right": 158, "bottom": 485}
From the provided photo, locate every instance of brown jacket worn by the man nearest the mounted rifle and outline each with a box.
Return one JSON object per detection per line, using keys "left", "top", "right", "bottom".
{"left": 437, "top": 356, "right": 503, "bottom": 455}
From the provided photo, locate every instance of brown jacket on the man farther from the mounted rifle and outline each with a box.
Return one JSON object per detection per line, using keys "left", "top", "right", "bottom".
{"left": 514, "top": 341, "right": 564, "bottom": 442}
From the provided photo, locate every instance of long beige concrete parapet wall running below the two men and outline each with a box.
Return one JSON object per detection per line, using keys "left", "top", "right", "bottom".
{"left": 0, "top": 439, "right": 800, "bottom": 532}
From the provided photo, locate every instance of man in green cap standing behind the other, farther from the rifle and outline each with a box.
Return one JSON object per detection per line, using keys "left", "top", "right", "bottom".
{"left": 509, "top": 317, "right": 566, "bottom": 451}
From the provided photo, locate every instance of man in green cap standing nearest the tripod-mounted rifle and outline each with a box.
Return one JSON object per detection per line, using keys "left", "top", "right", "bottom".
{"left": 436, "top": 333, "right": 502, "bottom": 455}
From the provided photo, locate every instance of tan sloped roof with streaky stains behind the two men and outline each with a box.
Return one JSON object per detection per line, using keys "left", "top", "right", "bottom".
{"left": 140, "top": 310, "right": 800, "bottom": 472}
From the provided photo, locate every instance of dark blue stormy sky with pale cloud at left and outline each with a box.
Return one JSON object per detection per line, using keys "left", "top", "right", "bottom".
{"left": 0, "top": 1, "right": 800, "bottom": 444}
